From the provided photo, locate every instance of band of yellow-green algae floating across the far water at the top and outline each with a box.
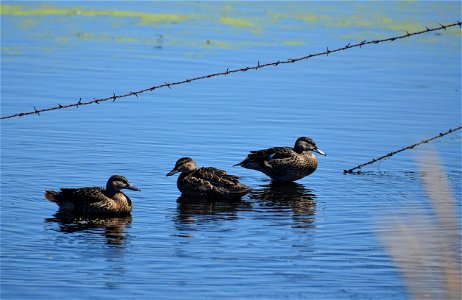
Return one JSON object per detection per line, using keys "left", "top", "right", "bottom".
{"left": 0, "top": 1, "right": 461, "bottom": 52}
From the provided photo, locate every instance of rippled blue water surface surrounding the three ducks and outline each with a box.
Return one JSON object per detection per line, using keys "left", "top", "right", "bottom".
{"left": 1, "top": 2, "right": 461, "bottom": 299}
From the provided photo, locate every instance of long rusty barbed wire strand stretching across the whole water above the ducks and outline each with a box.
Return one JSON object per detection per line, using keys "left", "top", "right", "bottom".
{"left": 0, "top": 21, "right": 462, "bottom": 120}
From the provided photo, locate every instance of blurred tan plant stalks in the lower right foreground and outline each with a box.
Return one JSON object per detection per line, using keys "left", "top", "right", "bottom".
{"left": 379, "top": 152, "right": 461, "bottom": 300}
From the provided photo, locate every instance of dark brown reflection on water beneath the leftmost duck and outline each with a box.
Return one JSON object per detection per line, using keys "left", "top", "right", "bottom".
{"left": 45, "top": 211, "right": 132, "bottom": 246}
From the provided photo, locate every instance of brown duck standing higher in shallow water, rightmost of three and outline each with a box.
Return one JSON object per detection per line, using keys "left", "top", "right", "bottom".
{"left": 234, "top": 137, "right": 326, "bottom": 182}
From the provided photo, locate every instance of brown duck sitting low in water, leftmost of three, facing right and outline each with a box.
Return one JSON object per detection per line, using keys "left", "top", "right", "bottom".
{"left": 44, "top": 175, "right": 140, "bottom": 215}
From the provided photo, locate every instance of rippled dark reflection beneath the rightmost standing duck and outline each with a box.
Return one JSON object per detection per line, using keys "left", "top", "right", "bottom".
{"left": 251, "top": 182, "right": 316, "bottom": 228}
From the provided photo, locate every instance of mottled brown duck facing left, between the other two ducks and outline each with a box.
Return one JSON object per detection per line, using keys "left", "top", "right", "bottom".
{"left": 166, "top": 157, "right": 250, "bottom": 199}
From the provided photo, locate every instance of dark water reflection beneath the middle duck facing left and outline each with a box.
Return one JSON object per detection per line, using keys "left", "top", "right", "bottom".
{"left": 176, "top": 195, "right": 252, "bottom": 230}
